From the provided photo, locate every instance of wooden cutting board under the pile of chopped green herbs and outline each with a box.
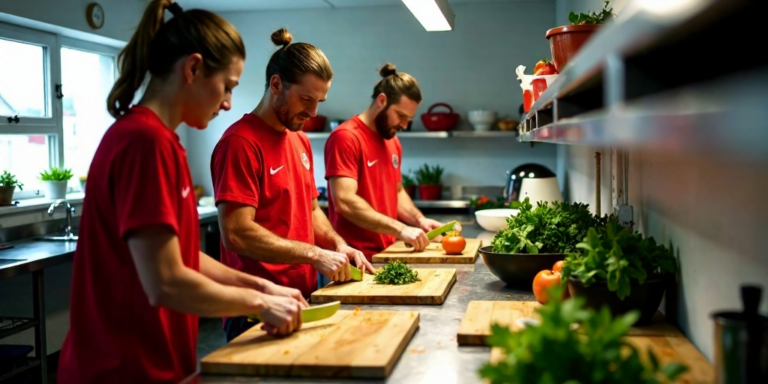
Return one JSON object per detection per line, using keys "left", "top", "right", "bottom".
{"left": 311, "top": 268, "right": 456, "bottom": 304}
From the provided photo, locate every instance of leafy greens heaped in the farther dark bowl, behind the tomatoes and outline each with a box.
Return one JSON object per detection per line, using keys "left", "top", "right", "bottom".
{"left": 491, "top": 197, "right": 613, "bottom": 254}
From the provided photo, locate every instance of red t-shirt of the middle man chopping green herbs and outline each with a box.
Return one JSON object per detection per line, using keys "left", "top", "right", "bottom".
{"left": 211, "top": 113, "right": 318, "bottom": 297}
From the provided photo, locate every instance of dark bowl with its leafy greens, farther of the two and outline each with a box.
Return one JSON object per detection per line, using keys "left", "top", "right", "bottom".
{"left": 480, "top": 197, "right": 608, "bottom": 290}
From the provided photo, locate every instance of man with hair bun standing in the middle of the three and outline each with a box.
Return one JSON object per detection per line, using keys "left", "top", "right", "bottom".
{"left": 211, "top": 28, "right": 373, "bottom": 341}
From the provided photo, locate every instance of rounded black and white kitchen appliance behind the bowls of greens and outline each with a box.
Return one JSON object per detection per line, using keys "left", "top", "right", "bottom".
{"left": 504, "top": 163, "right": 563, "bottom": 203}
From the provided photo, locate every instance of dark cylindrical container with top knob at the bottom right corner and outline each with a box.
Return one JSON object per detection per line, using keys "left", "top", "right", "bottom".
{"left": 712, "top": 285, "right": 768, "bottom": 384}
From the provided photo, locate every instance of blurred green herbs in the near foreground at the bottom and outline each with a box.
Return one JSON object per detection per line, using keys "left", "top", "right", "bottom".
{"left": 480, "top": 285, "right": 688, "bottom": 384}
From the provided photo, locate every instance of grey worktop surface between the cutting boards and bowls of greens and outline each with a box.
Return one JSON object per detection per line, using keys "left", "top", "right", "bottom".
{"left": 189, "top": 215, "right": 535, "bottom": 384}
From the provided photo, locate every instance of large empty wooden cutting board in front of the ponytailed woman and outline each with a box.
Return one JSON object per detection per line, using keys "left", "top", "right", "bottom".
{"left": 200, "top": 310, "right": 419, "bottom": 379}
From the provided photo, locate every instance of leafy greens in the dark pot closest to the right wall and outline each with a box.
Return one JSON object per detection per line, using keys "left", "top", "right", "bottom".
{"left": 562, "top": 222, "right": 677, "bottom": 300}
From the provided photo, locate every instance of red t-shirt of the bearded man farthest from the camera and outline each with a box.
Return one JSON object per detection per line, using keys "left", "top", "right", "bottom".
{"left": 325, "top": 116, "right": 403, "bottom": 260}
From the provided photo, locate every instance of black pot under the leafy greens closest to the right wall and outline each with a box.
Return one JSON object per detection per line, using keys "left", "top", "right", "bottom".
{"left": 568, "top": 277, "right": 665, "bottom": 325}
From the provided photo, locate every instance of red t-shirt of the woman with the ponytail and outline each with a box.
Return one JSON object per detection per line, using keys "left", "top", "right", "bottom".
{"left": 58, "top": 107, "right": 200, "bottom": 384}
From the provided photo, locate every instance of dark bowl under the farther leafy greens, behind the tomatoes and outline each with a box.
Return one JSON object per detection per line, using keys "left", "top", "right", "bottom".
{"left": 480, "top": 245, "right": 565, "bottom": 291}
